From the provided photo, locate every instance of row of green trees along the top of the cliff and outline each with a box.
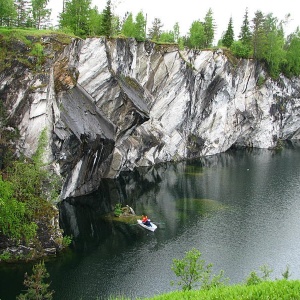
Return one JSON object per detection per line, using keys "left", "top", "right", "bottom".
{"left": 0, "top": 0, "right": 300, "bottom": 78}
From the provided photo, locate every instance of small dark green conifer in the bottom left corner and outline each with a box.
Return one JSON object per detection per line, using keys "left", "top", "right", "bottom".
{"left": 17, "top": 261, "right": 54, "bottom": 300}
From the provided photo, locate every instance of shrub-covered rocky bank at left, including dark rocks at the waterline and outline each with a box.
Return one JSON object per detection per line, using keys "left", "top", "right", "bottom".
{"left": 0, "top": 126, "right": 63, "bottom": 260}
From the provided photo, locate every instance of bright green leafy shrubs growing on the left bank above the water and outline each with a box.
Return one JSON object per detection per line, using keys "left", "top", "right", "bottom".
{"left": 0, "top": 130, "right": 58, "bottom": 243}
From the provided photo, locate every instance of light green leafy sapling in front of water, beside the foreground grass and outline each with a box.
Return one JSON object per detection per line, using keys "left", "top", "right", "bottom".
{"left": 171, "top": 248, "right": 223, "bottom": 291}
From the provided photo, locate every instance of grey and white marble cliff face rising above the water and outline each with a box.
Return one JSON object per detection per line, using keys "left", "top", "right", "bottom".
{"left": 0, "top": 38, "right": 300, "bottom": 199}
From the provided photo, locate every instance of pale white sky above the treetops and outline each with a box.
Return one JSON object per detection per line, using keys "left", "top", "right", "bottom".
{"left": 49, "top": 0, "right": 300, "bottom": 43}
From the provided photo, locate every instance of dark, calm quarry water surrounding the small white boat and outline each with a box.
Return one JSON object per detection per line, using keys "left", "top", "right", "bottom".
{"left": 0, "top": 145, "right": 300, "bottom": 300}
